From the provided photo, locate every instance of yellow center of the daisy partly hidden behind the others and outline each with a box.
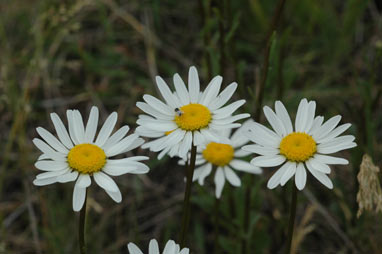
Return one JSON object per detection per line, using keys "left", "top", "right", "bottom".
{"left": 203, "top": 142, "right": 234, "bottom": 167}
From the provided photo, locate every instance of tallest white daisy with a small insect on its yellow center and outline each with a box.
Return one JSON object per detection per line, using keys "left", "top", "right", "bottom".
{"left": 137, "top": 67, "right": 249, "bottom": 158}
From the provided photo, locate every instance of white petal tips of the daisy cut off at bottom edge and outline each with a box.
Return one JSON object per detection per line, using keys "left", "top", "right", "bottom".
{"left": 127, "top": 239, "right": 189, "bottom": 254}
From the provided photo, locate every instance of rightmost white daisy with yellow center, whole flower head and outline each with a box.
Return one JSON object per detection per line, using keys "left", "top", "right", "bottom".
{"left": 242, "top": 99, "right": 356, "bottom": 190}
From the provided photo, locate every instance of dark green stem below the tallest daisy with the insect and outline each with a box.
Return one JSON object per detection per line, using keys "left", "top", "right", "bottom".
{"left": 179, "top": 144, "right": 196, "bottom": 248}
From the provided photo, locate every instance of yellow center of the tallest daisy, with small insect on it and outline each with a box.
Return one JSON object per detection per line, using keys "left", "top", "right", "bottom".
{"left": 174, "top": 104, "right": 211, "bottom": 131}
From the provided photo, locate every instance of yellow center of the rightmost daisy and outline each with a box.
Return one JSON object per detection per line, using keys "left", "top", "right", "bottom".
{"left": 280, "top": 132, "right": 317, "bottom": 162}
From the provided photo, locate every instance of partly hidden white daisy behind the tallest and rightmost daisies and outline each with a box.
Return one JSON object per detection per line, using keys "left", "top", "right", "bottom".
{"left": 179, "top": 120, "right": 262, "bottom": 198}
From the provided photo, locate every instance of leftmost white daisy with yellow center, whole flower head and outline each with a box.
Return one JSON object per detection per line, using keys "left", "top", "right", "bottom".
{"left": 33, "top": 107, "right": 149, "bottom": 211}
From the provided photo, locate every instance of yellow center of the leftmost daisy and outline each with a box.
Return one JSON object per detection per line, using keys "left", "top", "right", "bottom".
{"left": 68, "top": 144, "right": 106, "bottom": 174}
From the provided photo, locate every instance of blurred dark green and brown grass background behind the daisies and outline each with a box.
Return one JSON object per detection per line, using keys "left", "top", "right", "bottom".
{"left": 0, "top": 0, "right": 382, "bottom": 254}
